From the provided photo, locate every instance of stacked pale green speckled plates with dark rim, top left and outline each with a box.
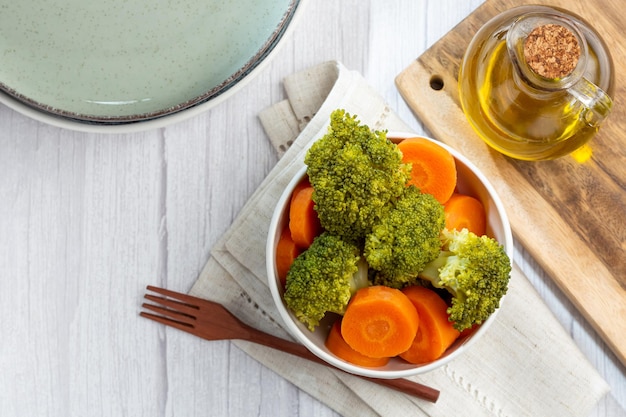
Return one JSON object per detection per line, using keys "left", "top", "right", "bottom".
{"left": 0, "top": 0, "right": 302, "bottom": 130}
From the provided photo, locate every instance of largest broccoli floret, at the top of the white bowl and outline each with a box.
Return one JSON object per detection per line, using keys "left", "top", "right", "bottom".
{"left": 304, "top": 110, "right": 411, "bottom": 241}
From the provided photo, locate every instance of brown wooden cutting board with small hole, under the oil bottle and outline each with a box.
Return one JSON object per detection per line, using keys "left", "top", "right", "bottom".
{"left": 396, "top": 0, "right": 626, "bottom": 365}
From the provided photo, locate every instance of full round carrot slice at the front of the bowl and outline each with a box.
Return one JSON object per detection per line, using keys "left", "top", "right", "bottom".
{"left": 341, "top": 285, "right": 419, "bottom": 358}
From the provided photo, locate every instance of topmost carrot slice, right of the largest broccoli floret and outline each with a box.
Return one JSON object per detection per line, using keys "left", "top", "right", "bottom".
{"left": 398, "top": 138, "right": 456, "bottom": 204}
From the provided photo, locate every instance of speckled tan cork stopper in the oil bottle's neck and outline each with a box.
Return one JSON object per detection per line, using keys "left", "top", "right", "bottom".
{"left": 524, "top": 23, "right": 581, "bottom": 79}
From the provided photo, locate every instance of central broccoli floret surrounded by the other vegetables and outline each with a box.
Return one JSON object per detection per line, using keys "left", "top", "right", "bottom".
{"left": 364, "top": 185, "right": 445, "bottom": 288}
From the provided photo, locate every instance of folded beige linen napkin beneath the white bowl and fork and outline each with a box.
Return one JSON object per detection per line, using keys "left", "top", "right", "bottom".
{"left": 191, "top": 62, "right": 608, "bottom": 417}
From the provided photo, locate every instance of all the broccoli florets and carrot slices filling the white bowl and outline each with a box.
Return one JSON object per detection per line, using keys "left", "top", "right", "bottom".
{"left": 276, "top": 110, "right": 511, "bottom": 367}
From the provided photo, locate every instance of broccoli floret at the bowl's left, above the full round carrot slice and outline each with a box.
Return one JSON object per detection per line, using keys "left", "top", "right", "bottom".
{"left": 284, "top": 232, "right": 369, "bottom": 331}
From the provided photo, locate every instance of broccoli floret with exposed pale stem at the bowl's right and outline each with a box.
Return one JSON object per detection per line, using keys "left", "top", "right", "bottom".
{"left": 419, "top": 229, "right": 511, "bottom": 331}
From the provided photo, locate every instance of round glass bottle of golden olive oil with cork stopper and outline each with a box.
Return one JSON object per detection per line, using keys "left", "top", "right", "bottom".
{"left": 459, "top": 6, "right": 612, "bottom": 160}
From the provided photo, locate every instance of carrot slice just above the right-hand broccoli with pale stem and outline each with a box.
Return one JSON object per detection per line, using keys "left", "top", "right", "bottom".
{"left": 443, "top": 193, "right": 487, "bottom": 236}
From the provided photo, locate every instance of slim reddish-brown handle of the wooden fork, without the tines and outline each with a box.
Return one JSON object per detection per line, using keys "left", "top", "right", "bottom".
{"left": 239, "top": 325, "right": 439, "bottom": 403}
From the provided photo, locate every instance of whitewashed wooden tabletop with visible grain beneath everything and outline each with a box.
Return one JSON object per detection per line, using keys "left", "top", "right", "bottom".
{"left": 0, "top": 0, "right": 626, "bottom": 417}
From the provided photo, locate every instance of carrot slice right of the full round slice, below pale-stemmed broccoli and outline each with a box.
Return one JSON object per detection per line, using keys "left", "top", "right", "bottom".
{"left": 399, "top": 285, "right": 460, "bottom": 364}
